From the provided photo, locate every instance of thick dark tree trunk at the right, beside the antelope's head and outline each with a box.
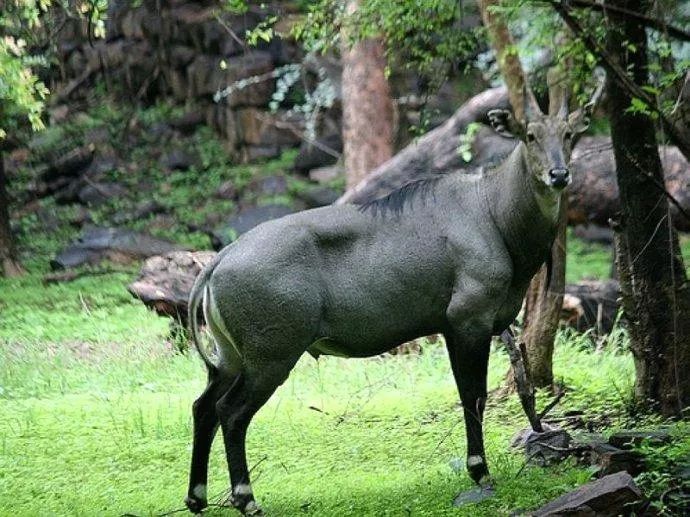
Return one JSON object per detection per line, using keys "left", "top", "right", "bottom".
{"left": 606, "top": 0, "right": 690, "bottom": 415}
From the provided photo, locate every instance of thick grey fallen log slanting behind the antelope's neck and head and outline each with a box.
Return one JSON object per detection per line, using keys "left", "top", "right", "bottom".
{"left": 337, "top": 88, "right": 690, "bottom": 231}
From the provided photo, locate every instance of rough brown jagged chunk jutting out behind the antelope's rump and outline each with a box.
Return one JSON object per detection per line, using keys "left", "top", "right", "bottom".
{"left": 127, "top": 251, "right": 216, "bottom": 326}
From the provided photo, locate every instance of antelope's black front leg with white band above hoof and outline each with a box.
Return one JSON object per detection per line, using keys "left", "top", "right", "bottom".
{"left": 446, "top": 333, "right": 491, "bottom": 486}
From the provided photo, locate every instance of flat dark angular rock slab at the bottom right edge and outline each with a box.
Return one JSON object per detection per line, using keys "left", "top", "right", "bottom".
{"left": 530, "top": 472, "right": 642, "bottom": 517}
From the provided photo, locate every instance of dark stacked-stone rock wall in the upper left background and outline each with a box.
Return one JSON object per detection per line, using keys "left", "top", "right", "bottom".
{"left": 51, "top": 0, "right": 303, "bottom": 161}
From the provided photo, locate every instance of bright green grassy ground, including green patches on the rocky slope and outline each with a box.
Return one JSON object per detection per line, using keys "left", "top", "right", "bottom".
{"left": 0, "top": 98, "right": 690, "bottom": 516}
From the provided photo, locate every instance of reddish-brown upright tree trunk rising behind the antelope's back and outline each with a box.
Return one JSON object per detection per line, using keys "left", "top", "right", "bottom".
{"left": 342, "top": 0, "right": 395, "bottom": 188}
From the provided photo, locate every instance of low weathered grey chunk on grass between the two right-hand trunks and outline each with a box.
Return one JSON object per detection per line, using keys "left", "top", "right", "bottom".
{"left": 561, "top": 280, "right": 620, "bottom": 334}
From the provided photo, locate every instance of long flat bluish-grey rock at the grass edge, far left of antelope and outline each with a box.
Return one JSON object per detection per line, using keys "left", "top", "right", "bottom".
{"left": 50, "top": 227, "right": 181, "bottom": 270}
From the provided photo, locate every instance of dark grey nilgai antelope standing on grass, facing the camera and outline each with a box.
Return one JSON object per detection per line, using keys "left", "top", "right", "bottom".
{"left": 185, "top": 78, "right": 591, "bottom": 515}
